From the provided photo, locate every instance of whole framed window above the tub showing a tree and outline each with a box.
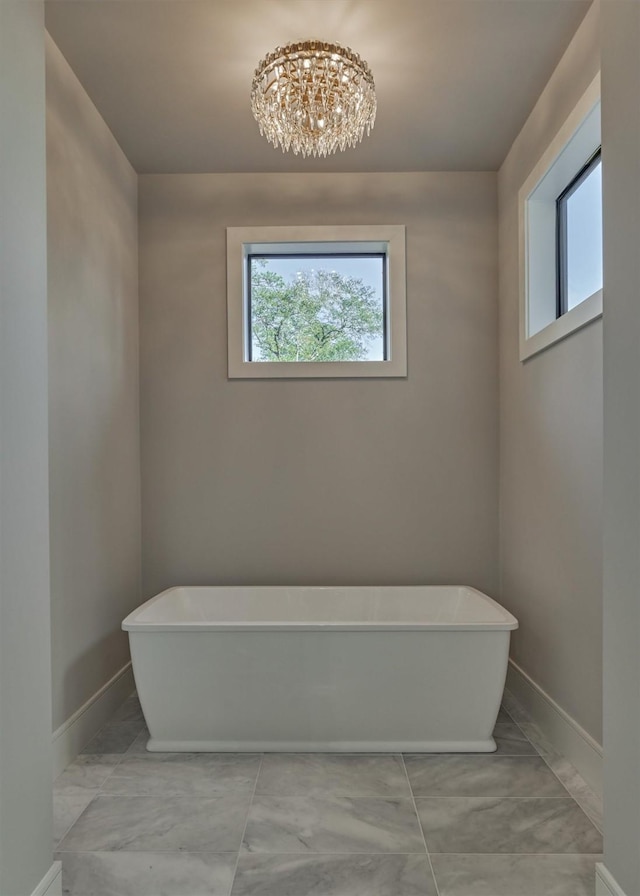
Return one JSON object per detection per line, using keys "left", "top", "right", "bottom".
{"left": 227, "top": 225, "right": 406, "bottom": 378}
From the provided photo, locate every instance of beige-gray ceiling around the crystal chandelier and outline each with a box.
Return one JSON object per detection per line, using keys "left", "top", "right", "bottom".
{"left": 46, "top": 0, "right": 591, "bottom": 173}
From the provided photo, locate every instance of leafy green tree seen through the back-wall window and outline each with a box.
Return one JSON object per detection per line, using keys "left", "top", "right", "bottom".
{"left": 250, "top": 257, "right": 384, "bottom": 361}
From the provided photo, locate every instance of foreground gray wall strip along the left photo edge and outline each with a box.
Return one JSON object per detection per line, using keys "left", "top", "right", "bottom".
{"left": 0, "top": 0, "right": 52, "bottom": 896}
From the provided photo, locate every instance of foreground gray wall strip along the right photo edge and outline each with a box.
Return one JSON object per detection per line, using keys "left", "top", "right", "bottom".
{"left": 602, "top": 0, "right": 640, "bottom": 896}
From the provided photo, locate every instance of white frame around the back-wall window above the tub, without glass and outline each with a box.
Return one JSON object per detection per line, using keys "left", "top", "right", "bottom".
{"left": 227, "top": 224, "right": 407, "bottom": 379}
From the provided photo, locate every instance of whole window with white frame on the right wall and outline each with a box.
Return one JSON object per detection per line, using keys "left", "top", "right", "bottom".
{"left": 519, "top": 77, "right": 602, "bottom": 361}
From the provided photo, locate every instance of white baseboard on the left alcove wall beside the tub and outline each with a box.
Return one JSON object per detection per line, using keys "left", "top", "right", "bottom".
{"left": 52, "top": 662, "right": 135, "bottom": 779}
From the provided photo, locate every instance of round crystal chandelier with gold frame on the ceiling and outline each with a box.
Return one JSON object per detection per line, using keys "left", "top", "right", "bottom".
{"left": 251, "top": 40, "right": 376, "bottom": 156}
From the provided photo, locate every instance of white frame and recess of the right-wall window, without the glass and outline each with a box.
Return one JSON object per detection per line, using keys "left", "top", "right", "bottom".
{"left": 518, "top": 74, "right": 602, "bottom": 361}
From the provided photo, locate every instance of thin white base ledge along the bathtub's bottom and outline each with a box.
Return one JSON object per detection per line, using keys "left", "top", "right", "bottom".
{"left": 142, "top": 737, "right": 497, "bottom": 753}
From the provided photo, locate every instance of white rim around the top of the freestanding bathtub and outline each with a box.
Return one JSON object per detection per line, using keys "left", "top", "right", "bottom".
{"left": 122, "top": 585, "right": 519, "bottom": 634}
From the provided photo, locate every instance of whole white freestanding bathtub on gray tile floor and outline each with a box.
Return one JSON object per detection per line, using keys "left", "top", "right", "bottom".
{"left": 122, "top": 586, "right": 518, "bottom": 753}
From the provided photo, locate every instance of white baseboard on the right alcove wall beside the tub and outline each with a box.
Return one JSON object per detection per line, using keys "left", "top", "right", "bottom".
{"left": 506, "top": 660, "right": 602, "bottom": 797}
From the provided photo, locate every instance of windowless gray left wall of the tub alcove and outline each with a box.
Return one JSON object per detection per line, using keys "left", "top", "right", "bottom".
{"left": 46, "top": 38, "right": 140, "bottom": 727}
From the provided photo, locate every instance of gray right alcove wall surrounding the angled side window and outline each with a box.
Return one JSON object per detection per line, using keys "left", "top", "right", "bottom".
{"left": 498, "top": 5, "right": 602, "bottom": 742}
